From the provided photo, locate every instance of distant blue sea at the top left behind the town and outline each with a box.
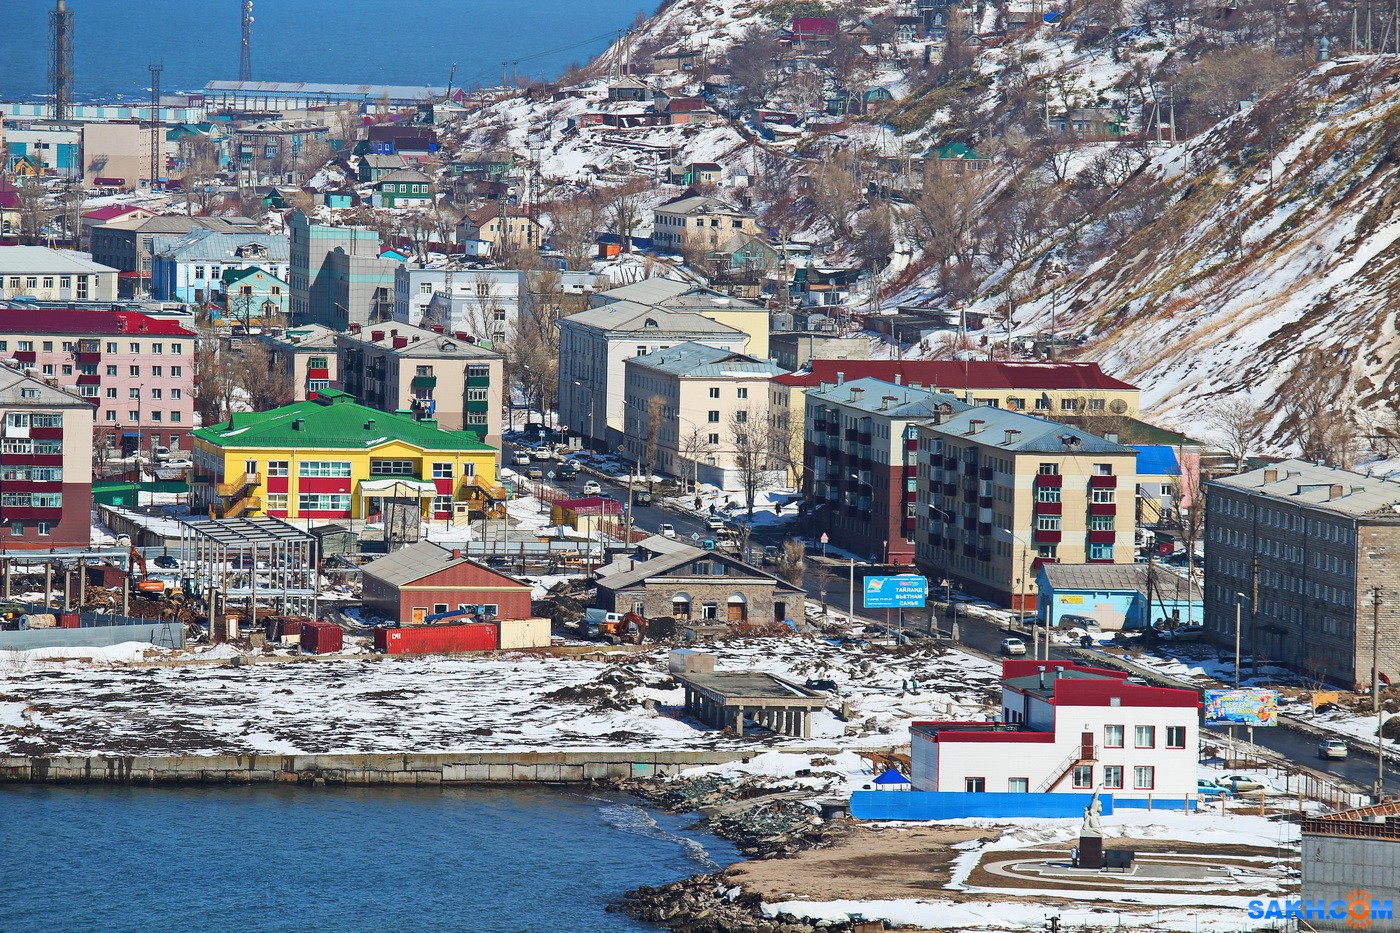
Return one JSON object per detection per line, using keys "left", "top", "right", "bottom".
{"left": 0, "top": 0, "right": 644, "bottom": 101}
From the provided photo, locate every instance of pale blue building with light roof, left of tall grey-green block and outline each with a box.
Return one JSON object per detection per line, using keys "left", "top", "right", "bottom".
{"left": 151, "top": 228, "right": 291, "bottom": 304}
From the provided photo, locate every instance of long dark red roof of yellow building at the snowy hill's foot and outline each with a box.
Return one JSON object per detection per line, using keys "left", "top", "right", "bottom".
{"left": 780, "top": 360, "right": 1137, "bottom": 391}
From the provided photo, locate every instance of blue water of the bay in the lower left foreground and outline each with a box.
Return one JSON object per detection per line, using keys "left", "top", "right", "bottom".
{"left": 0, "top": 785, "right": 738, "bottom": 933}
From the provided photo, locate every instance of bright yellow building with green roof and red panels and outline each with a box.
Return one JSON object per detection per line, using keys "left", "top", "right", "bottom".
{"left": 190, "top": 389, "right": 505, "bottom": 520}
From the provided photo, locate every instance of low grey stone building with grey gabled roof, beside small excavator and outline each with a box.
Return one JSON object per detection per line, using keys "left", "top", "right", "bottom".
{"left": 598, "top": 535, "right": 804, "bottom": 625}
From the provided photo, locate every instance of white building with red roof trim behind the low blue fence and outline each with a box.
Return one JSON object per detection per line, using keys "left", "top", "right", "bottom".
{"left": 910, "top": 660, "right": 1200, "bottom": 803}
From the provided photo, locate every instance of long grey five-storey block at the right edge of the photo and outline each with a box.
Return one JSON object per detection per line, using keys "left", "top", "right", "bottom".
{"left": 1205, "top": 459, "right": 1400, "bottom": 686}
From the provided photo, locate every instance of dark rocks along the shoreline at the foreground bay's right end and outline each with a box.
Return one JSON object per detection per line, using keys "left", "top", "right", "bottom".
{"left": 609, "top": 775, "right": 855, "bottom": 933}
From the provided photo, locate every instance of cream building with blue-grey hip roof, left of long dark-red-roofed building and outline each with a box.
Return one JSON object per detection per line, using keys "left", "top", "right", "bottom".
{"left": 623, "top": 343, "right": 783, "bottom": 489}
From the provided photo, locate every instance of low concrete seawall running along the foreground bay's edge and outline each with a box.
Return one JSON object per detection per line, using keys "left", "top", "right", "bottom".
{"left": 0, "top": 748, "right": 837, "bottom": 786}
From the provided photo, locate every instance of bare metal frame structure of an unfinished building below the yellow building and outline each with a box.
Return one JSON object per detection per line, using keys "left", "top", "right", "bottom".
{"left": 181, "top": 516, "right": 318, "bottom": 632}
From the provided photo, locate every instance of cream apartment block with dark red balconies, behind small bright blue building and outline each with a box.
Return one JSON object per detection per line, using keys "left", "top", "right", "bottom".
{"left": 914, "top": 405, "right": 1137, "bottom": 612}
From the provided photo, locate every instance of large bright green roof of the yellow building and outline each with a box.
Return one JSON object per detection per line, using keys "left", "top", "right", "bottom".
{"left": 195, "top": 389, "right": 496, "bottom": 452}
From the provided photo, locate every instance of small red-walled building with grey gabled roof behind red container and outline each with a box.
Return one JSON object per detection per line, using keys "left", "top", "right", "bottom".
{"left": 363, "top": 541, "right": 531, "bottom": 625}
